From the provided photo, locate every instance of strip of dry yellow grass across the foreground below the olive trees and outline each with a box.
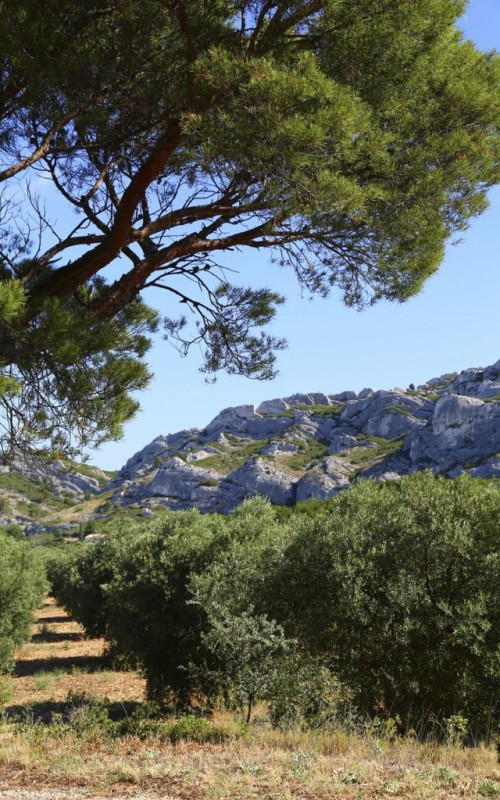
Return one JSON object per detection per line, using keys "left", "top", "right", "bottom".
{"left": 0, "top": 732, "right": 500, "bottom": 800}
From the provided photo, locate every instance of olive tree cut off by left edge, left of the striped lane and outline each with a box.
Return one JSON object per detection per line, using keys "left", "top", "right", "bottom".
{"left": 0, "top": 532, "right": 46, "bottom": 674}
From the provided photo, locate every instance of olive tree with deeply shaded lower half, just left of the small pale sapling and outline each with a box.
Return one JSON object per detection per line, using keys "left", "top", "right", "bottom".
{"left": 105, "top": 511, "right": 232, "bottom": 707}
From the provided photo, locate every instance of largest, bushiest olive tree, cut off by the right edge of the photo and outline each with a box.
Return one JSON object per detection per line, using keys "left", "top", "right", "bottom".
{"left": 263, "top": 473, "right": 500, "bottom": 737}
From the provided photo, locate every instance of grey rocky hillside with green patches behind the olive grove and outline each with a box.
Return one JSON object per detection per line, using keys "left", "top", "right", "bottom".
{"left": 0, "top": 361, "right": 500, "bottom": 532}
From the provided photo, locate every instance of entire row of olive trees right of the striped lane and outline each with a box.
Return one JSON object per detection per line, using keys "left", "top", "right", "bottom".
{"left": 51, "top": 474, "right": 500, "bottom": 737}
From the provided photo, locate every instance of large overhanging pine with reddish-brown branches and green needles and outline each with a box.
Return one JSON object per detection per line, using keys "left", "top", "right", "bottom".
{"left": 0, "top": 0, "right": 500, "bottom": 451}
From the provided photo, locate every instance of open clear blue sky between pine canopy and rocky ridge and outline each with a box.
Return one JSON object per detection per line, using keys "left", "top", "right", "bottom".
{"left": 91, "top": 0, "right": 500, "bottom": 469}
